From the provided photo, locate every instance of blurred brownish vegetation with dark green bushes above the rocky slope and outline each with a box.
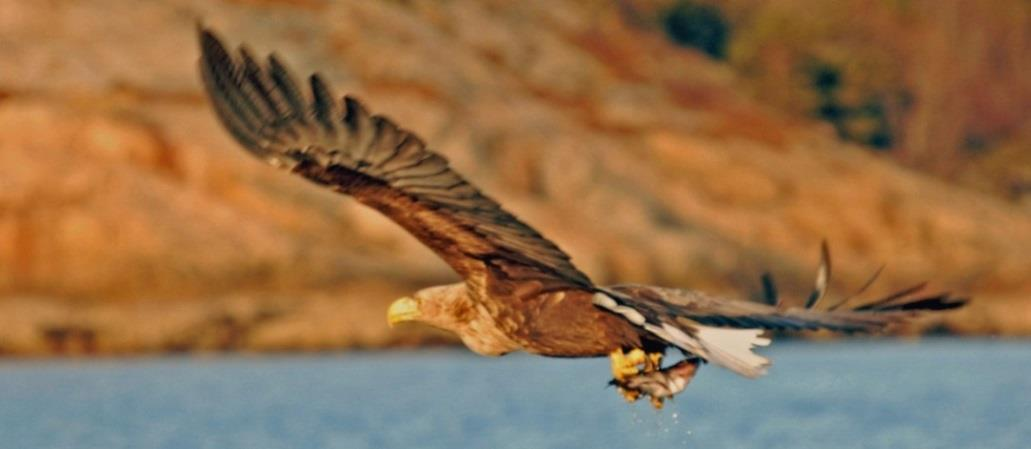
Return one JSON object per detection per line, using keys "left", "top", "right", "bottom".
{"left": 643, "top": 0, "right": 1031, "bottom": 200}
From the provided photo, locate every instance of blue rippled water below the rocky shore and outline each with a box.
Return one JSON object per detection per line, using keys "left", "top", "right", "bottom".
{"left": 0, "top": 340, "right": 1031, "bottom": 449}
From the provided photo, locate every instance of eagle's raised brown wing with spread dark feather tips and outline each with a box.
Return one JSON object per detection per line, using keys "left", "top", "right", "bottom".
{"left": 200, "top": 29, "right": 591, "bottom": 293}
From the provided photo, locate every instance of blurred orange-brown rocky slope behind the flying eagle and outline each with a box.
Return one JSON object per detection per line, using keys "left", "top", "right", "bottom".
{"left": 0, "top": 0, "right": 1031, "bottom": 354}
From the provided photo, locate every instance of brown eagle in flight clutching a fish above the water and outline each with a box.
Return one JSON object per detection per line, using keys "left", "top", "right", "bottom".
{"left": 199, "top": 27, "right": 965, "bottom": 407}
